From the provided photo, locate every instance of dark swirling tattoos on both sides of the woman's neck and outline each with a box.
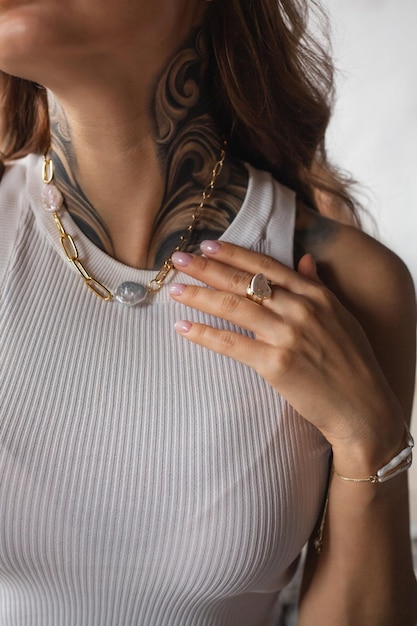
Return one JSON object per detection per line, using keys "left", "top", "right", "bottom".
{"left": 50, "top": 31, "right": 247, "bottom": 267}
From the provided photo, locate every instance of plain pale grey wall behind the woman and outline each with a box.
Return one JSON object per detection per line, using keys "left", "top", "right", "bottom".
{"left": 323, "top": 0, "right": 417, "bottom": 537}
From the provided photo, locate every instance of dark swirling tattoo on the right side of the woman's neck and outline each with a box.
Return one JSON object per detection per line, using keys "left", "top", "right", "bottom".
{"left": 150, "top": 31, "right": 247, "bottom": 265}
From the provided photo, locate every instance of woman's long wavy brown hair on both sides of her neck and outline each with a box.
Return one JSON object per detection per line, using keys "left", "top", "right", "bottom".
{"left": 1, "top": 0, "right": 358, "bottom": 223}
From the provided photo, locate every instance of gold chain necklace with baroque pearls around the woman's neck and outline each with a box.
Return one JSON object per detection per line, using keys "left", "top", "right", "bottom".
{"left": 42, "top": 141, "right": 227, "bottom": 306}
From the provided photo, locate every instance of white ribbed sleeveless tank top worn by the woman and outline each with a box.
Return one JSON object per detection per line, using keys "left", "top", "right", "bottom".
{"left": 0, "top": 156, "right": 328, "bottom": 626}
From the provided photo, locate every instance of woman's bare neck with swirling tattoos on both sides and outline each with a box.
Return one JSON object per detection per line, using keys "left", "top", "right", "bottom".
{"left": 49, "top": 32, "right": 246, "bottom": 267}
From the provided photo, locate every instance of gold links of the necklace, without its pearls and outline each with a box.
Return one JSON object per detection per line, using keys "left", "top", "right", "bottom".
{"left": 42, "top": 141, "right": 227, "bottom": 302}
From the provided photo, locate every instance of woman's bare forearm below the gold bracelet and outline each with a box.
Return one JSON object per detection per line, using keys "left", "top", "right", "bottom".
{"left": 299, "top": 456, "right": 417, "bottom": 626}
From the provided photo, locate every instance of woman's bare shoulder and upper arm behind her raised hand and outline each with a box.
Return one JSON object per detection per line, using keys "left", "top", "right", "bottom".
{"left": 295, "top": 202, "right": 416, "bottom": 415}
